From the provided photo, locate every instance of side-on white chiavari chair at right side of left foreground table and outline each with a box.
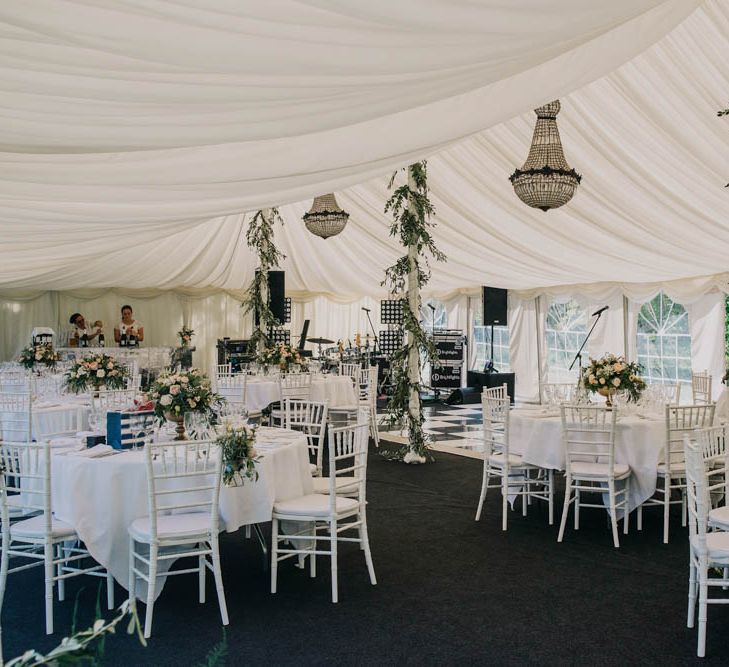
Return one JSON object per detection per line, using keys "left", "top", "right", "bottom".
{"left": 271, "top": 423, "right": 377, "bottom": 602}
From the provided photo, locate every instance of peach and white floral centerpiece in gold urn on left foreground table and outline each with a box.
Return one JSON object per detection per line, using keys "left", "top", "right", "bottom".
{"left": 149, "top": 368, "right": 223, "bottom": 440}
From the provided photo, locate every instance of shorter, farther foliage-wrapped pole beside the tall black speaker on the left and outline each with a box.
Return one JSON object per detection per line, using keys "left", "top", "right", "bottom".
{"left": 241, "top": 208, "right": 286, "bottom": 350}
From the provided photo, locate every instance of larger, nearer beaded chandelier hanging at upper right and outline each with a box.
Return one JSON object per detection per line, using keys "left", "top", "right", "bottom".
{"left": 509, "top": 100, "right": 582, "bottom": 211}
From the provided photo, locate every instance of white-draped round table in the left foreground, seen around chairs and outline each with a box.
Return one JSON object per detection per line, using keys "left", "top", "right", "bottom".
{"left": 51, "top": 427, "right": 313, "bottom": 599}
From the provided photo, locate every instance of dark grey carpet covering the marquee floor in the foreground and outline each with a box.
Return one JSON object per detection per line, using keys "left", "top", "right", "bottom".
{"left": 3, "top": 446, "right": 729, "bottom": 665}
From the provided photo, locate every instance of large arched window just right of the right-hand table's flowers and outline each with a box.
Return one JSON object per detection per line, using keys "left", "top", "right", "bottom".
{"left": 637, "top": 292, "right": 691, "bottom": 384}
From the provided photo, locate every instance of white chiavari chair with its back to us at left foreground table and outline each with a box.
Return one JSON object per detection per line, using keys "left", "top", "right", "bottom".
{"left": 129, "top": 440, "right": 228, "bottom": 637}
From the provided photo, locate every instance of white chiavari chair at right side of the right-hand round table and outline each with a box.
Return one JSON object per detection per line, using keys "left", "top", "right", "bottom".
{"left": 638, "top": 403, "right": 716, "bottom": 544}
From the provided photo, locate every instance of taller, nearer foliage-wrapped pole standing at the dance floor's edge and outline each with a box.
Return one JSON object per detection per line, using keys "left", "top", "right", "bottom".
{"left": 382, "top": 160, "right": 446, "bottom": 463}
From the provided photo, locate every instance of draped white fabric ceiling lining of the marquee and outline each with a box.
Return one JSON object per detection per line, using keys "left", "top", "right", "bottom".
{"left": 0, "top": 0, "right": 729, "bottom": 300}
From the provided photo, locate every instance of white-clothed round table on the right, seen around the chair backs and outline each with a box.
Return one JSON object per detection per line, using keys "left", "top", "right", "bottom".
{"left": 509, "top": 408, "right": 666, "bottom": 511}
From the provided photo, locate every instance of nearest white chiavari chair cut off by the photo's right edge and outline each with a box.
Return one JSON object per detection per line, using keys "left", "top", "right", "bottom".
{"left": 684, "top": 436, "right": 729, "bottom": 658}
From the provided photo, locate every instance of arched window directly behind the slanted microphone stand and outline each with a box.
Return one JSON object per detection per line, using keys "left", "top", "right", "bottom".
{"left": 545, "top": 299, "right": 588, "bottom": 382}
